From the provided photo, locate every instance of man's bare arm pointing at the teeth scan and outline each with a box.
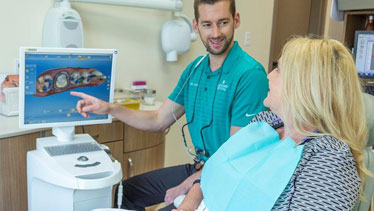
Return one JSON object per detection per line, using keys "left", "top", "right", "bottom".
{"left": 71, "top": 92, "right": 184, "bottom": 132}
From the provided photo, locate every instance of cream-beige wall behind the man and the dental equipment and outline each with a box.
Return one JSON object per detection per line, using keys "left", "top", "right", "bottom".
{"left": 0, "top": 0, "right": 273, "bottom": 165}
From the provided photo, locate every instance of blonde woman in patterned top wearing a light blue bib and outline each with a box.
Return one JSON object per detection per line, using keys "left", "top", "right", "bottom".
{"left": 177, "top": 37, "right": 368, "bottom": 211}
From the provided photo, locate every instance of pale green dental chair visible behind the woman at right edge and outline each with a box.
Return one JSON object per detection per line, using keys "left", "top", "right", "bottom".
{"left": 355, "top": 93, "right": 374, "bottom": 211}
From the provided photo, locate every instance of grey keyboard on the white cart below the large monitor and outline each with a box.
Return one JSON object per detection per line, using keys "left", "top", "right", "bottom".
{"left": 45, "top": 142, "right": 102, "bottom": 157}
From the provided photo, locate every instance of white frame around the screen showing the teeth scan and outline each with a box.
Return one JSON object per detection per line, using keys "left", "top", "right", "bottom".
{"left": 19, "top": 47, "right": 118, "bottom": 129}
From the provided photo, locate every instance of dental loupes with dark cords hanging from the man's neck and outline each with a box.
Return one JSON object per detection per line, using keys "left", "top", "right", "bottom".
{"left": 172, "top": 54, "right": 223, "bottom": 160}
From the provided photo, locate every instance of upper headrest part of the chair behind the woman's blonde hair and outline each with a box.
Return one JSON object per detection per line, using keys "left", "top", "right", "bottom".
{"left": 363, "top": 93, "right": 374, "bottom": 147}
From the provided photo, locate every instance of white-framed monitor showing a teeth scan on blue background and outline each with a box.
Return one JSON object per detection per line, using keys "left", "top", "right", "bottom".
{"left": 19, "top": 48, "right": 117, "bottom": 128}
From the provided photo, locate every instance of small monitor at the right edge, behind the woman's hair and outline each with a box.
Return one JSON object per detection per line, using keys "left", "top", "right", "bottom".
{"left": 353, "top": 31, "right": 374, "bottom": 78}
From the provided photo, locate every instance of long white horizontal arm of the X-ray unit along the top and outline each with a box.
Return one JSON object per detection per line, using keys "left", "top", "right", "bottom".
{"left": 70, "top": 0, "right": 183, "bottom": 12}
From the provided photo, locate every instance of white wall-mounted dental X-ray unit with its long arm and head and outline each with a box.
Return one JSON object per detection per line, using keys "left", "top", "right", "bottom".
{"left": 43, "top": 0, "right": 196, "bottom": 61}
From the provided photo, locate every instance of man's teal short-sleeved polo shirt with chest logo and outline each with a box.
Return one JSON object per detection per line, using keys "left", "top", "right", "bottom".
{"left": 169, "top": 41, "right": 269, "bottom": 160}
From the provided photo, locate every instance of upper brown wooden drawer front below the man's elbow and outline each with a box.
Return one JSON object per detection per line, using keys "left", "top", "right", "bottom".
{"left": 123, "top": 124, "right": 165, "bottom": 152}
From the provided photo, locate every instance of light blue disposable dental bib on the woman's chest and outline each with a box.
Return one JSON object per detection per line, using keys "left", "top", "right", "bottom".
{"left": 201, "top": 122, "right": 304, "bottom": 211}
